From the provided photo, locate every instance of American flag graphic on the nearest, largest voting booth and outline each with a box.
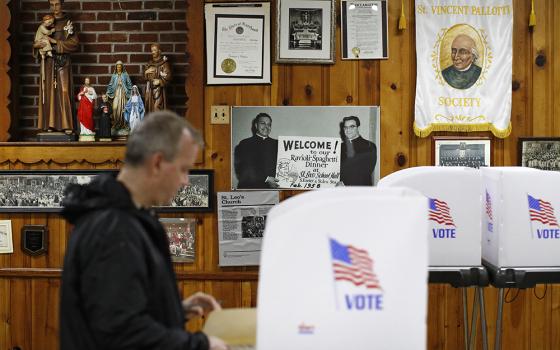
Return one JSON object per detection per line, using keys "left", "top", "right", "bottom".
{"left": 330, "top": 238, "right": 381, "bottom": 289}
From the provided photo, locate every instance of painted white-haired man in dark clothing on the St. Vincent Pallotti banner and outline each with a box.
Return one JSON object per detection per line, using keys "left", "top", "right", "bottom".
{"left": 441, "top": 34, "right": 482, "bottom": 90}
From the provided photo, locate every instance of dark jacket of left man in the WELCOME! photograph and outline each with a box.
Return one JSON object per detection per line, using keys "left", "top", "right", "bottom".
{"left": 233, "top": 135, "right": 278, "bottom": 189}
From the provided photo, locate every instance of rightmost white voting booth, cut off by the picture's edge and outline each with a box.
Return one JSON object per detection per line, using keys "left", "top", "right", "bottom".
{"left": 482, "top": 167, "right": 560, "bottom": 267}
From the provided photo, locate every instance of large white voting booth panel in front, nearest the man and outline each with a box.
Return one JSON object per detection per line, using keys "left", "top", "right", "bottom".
{"left": 257, "top": 187, "right": 428, "bottom": 350}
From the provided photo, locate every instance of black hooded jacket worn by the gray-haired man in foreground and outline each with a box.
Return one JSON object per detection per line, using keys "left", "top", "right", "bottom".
{"left": 60, "top": 176, "right": 208, "bottom": 350}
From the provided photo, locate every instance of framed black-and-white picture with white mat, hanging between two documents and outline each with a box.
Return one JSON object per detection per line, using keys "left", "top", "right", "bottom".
{"left": 276, "top": 0, "right": 335, "bottom": 64}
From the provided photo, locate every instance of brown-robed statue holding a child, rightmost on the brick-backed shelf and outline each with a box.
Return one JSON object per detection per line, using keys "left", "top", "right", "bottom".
{"left": 144, "top": 44, "right": 171, "bottom": 113}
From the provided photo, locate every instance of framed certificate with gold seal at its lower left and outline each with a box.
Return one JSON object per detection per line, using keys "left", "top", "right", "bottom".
{"left": 204, "top": 2, "right": 271, "bottom": 85}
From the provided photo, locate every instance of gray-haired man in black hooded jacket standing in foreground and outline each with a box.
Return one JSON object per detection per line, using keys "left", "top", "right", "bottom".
{"left": 60, "top": 111, "right": 227, "bottom": 350}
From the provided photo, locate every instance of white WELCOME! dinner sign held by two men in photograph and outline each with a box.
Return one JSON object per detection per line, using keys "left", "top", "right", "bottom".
{"left": 276, "top": 136, "right": 341, "bottom": 189}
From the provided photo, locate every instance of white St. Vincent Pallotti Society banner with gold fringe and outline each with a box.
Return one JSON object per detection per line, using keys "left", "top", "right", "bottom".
{"left": 414, "top": 0, "right": 513, "bottom": 138}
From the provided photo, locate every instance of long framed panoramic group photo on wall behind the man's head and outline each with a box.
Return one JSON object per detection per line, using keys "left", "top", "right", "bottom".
{"left": 0, "top": 169, "right": 214, "bottom": 212}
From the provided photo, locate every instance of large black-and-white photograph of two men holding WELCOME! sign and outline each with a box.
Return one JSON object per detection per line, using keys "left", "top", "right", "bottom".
{"left": 231, "top": 106, "right": 380, "bottom": 190}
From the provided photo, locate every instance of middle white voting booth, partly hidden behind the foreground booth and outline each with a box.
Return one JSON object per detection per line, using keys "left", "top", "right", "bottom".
{"left": 378, "top": 166, "right": 482, "bottom": 266}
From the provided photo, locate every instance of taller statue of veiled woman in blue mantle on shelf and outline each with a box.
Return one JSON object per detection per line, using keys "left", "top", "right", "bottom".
{"left": 107, "top": 61, "right": 132, "bottom": 135}
